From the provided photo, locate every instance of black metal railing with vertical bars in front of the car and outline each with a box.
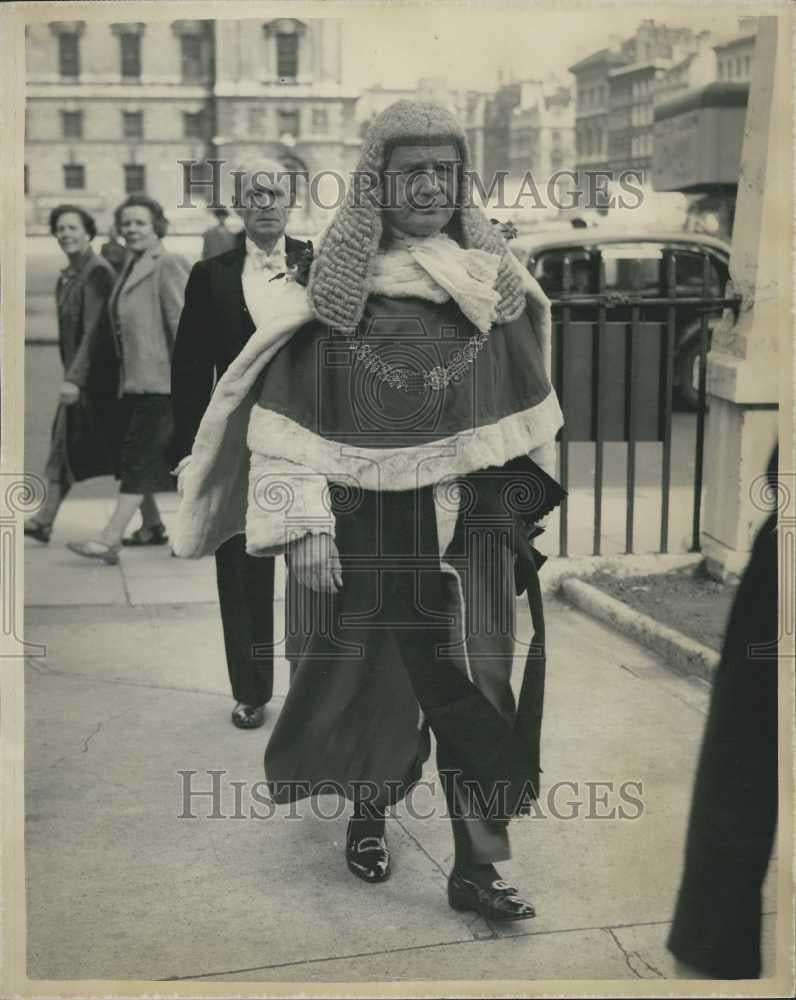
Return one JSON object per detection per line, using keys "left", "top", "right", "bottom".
{"left": 551, "top": 250, "right": 741, "bottom": 556}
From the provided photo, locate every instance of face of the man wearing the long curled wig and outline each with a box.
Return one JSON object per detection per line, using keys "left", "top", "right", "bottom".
{"left": 383, "top": 145, "right": 461, "bottom": 236}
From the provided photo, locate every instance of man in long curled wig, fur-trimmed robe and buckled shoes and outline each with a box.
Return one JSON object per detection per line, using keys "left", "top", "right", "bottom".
{"left": 177, "top": 101, "right": 562, "bottom": 920}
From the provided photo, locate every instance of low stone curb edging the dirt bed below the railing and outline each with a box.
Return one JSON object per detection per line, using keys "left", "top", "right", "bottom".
{"left": 561, "top": 579, "right": 719, "bottom": 681}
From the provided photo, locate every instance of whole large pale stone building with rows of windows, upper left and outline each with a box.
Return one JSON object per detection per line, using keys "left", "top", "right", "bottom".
{"left": 24, "top": 18, "right": 359, "bottom": 232}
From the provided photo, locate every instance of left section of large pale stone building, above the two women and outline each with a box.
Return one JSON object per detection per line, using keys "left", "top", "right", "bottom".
{"left": 25, "top": 20, "right": 213, "bottom": 229}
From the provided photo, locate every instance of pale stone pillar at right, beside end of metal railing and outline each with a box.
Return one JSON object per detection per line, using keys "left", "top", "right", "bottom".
{"left": 701, "top": 17, "right": 792, "bottom": 579}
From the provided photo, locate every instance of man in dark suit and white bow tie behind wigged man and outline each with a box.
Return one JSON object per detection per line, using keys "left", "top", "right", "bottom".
{"left": 171, "top": 160, "right": 306, "bottom": 729}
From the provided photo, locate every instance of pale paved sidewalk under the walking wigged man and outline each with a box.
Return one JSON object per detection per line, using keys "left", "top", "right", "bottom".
{"left": 25, "top": 500, "right": 775, "bottom": 984}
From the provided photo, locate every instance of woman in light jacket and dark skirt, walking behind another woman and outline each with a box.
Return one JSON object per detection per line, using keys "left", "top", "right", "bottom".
{"left": 68, "top": 194, "right": 190, "bottom": 564}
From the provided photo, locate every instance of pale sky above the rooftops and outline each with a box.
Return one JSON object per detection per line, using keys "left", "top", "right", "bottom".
{"left": 343, "top": 2, "right": 750, "bottom": 90}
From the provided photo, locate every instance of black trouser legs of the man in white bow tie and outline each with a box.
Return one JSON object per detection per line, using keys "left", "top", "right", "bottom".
{"left": 216, "top": 535, "right": 274, "bottom": 705}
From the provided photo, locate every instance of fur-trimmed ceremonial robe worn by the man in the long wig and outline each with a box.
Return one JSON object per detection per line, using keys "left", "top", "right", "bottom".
{"left": 175, "top": 256, "right": 562, "bottom": 820}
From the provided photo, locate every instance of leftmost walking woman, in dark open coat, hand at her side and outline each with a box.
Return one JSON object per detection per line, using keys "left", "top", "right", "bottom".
{"left": 25, "top": 205, "right": 118, "bottom": 543}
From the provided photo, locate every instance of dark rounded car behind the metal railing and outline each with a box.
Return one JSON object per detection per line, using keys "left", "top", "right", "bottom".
{"left": 509, "top": 228, "right": 730, "bottom": 409}
